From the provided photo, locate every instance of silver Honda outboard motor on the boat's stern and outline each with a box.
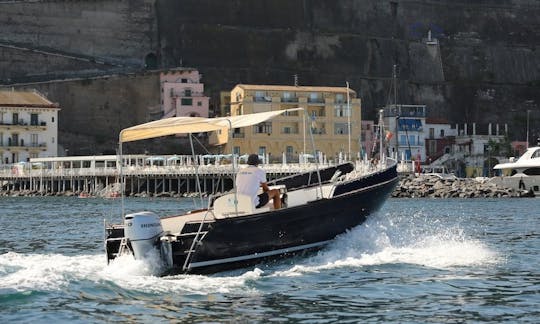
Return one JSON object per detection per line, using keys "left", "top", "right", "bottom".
{"left": 124, "top": 212, "right": 163, "bottom": 260}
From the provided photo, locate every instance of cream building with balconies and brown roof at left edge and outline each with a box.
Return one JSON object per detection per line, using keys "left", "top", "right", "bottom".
{"left": 0, "top": 90, "right": 60, "bottom": 164}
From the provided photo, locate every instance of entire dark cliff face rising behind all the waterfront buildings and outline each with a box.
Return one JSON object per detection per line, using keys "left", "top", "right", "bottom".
{"left": 0, "top": 0, "right": 540, "bottom": 152}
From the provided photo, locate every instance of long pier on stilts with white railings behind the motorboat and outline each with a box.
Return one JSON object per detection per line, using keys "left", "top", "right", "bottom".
{"left": 0, "top": 155, "right": 324, "bottom": 197}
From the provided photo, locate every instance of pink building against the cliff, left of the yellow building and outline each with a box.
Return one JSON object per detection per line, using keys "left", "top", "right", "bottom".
{"left": 160, "top": 68, "right": 209, "bottom": 118}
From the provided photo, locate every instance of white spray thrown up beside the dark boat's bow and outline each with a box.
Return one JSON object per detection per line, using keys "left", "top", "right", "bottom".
{"left": 276, "top": 208, "right": 501, "bottom": 276}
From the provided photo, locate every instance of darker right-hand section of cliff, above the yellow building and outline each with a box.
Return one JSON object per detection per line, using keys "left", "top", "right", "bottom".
{"left": 157, "top": 0, "right": 540, "bottom": 126}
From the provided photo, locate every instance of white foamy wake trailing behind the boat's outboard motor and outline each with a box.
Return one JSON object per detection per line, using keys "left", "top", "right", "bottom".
{"left": 0, "top": 252, "right": 263, "bottom": 295}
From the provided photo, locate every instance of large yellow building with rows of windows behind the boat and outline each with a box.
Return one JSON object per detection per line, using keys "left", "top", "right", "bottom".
{"left": 211, "top": 84, "right": 361, "bottom": 162}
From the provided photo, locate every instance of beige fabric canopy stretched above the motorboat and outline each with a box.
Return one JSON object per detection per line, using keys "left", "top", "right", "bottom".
{"left": 119, "top": 108, "right": 302, "bottom": 143}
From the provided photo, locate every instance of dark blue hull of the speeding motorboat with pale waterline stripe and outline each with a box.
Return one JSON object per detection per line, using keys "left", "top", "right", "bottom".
{"left": 179, "top": 166, "right": 398, "bottom": 273}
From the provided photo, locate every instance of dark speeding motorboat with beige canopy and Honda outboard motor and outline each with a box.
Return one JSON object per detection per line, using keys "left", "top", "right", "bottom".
{"left": 105, "top": 109, "right": 398, "bottom": 275}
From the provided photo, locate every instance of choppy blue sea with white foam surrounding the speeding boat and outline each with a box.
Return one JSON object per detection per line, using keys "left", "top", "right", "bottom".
{"left": 0, "top": 197, "right": 540, "bottom": 323}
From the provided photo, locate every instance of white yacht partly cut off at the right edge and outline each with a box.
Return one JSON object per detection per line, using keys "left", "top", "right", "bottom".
{"left": 491, "top": 146, "right": 540, "bottom": 196}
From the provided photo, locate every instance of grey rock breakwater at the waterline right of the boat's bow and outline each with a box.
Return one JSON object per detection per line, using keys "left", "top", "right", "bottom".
{"left": 392, "top": 175, "right": 529, "bottom": 198}
